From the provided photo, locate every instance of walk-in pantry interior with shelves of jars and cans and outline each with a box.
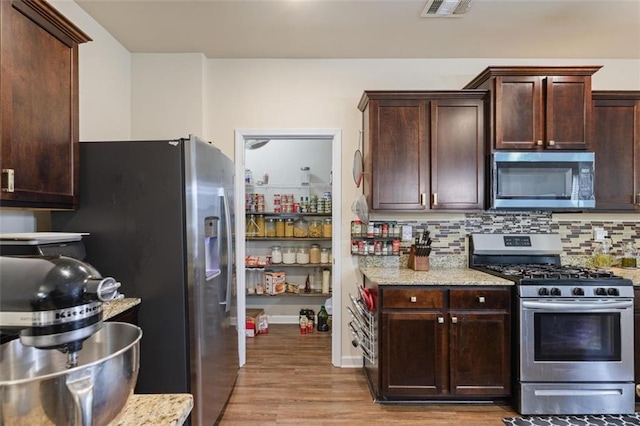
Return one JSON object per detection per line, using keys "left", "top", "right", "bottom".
{"left": 237, "top": 136, "right": 337, "bottom": 362}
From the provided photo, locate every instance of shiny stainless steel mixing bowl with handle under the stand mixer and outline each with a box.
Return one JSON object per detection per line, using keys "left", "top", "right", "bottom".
{"left": 0, "top": 322, "right": 142, "bottom": 426}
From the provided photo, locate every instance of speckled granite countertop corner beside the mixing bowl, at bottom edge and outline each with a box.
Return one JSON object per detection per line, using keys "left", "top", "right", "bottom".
{"left": 109, "top": 393, "right": 193, "bottom": 426}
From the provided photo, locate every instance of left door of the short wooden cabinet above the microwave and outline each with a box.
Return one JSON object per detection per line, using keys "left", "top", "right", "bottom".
{"left": 494, "top": 76, "right": 544, "bottom": 149}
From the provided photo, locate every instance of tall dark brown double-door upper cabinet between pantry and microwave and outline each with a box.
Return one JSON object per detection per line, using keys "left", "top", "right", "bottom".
{"left": 358, "top": 90, "right": 486, "bottom": 212}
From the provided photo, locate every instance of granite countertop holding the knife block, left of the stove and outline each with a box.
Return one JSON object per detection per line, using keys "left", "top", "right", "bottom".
{"left": 360, "top": 267, "right": 513, "bottom": 285}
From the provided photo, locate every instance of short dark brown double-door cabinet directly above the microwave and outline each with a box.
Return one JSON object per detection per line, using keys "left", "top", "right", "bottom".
{"left": 464, "top": 66, "right": 601, "bottom": 150}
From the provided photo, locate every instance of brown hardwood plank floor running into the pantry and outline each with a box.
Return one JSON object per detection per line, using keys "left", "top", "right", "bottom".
{"left": 219, "top": 324, "right": 517, "bottom": 426}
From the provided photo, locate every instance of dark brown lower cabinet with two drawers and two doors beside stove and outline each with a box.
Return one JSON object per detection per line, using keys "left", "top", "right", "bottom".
{"left": 370, "top": 286, "right": 511, "bottom": 401}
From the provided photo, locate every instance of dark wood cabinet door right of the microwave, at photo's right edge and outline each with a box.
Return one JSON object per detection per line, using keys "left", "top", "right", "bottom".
{"left": 592, "top": 92, "right": 640, "bottom": 211}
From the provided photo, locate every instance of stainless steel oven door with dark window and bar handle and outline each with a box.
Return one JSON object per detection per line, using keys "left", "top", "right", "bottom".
{"left": 520, "top": 299, "right": 634, "bottom": 382}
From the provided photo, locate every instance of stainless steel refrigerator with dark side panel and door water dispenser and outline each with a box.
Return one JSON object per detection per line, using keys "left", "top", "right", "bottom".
{"left": 51, "top": 136, "right": 239, "bottom": 425}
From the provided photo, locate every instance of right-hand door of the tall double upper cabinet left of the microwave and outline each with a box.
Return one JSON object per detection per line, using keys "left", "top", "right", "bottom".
{"left": 431, "top": 99, "right": 484, "bottom": 210}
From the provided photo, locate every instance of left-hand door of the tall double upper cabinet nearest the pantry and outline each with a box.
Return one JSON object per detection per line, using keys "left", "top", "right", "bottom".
{"left": 365, "top": 100, "right": 429, "bottom": 211}
